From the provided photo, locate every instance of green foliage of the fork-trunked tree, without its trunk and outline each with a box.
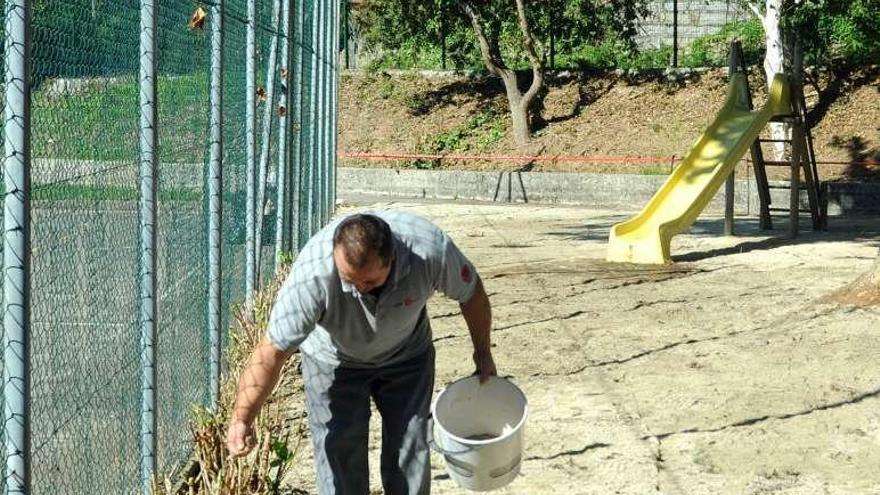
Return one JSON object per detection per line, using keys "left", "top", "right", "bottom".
{"left": 357, "top": 0, "right": 648, "bottom": 68}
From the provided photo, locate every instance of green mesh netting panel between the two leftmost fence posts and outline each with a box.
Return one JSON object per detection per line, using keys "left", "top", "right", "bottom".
{"left": 31, "top": 0, "right": 141, "bottom": 493}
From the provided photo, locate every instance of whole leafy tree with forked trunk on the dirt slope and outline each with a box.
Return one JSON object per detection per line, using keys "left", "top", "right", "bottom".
{"left": 360, "top": 0, "right": 647, "bottom": 147}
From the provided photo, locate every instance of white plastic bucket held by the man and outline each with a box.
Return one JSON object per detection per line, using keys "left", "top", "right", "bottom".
{"left": 431, "top": 376, "right": 528, "bottom": 491}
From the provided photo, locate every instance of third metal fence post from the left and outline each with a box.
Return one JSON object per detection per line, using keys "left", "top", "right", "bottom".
{"left": 208, "top": 0, "right": 223, "bottom": 410}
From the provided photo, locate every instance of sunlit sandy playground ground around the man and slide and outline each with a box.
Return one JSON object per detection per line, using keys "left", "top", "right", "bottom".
{"left": 280, "top": 202, "right": 880, "bottom": 495}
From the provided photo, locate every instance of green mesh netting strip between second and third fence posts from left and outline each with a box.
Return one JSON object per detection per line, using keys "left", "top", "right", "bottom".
{"left": 156, "top": 0, "right": 210, "bottom": 478}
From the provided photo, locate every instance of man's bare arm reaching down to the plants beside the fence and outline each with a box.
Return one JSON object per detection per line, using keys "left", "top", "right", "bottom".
{"left": 226, "top": 338, "right": 293, "bottom": 456}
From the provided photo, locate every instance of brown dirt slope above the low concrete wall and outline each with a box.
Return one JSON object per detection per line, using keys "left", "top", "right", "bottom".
{"left": 339, "top": 67, "right": 880, "bottom": 181}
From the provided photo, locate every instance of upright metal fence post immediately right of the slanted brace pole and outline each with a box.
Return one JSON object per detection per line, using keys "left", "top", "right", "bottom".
{"left": 275, "top": 0, "right": 293, "bottom": 274}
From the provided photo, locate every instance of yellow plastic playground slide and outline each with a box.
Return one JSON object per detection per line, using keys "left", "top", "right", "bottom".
{"left": 608, "top": 73, "right": 790, "bottom": 264}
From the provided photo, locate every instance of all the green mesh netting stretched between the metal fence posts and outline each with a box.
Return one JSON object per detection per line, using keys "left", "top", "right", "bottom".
{"left": 0, "top": 0, "right": 335, "bottom": 493}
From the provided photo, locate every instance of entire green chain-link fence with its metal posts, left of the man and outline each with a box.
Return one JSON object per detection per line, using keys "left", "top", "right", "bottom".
{"left": 2, "top": 0, "right": 339, "bottom": 494}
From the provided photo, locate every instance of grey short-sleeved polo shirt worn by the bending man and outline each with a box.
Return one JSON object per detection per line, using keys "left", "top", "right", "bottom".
{"left": 268, "top": 211, "right": 478, "bottom": 368}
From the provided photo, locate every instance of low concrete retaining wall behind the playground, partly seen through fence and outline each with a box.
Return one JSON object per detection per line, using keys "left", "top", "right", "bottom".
{"left": 32, "top": 159, "right": 880, "bottom": 215}
